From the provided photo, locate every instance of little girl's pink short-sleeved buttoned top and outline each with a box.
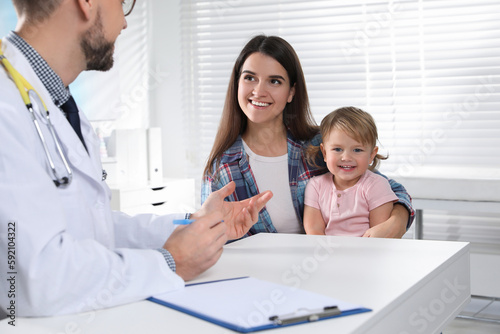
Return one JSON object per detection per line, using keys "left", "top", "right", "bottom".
{"left": 304, "top": 170, "right": 398, "bottom": 237}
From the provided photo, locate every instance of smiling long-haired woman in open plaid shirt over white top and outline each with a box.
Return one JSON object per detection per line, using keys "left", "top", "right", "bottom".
{"left": 202, "top": 35, "right": 413, "bottom": 237}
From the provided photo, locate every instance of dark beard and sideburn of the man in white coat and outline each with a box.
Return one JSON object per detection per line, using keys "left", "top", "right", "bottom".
{"left": 80, "top": 9, "right": 115, "bottom": 71}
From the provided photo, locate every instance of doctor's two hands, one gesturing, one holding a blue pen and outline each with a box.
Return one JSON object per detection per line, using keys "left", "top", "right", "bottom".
{"left": 163, "top": 182, "right": 273, "bottom": 281}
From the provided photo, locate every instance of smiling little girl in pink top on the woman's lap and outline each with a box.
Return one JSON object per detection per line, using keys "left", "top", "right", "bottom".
{"left": 304, "top": 107, "right": 397, "bottom": 236}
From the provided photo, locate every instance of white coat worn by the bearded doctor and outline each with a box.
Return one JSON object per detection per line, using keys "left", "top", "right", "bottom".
{"left": 0, "top": 39, "right": 184, "bottom": 316}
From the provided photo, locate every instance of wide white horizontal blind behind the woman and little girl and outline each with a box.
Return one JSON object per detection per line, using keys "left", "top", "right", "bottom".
{"left": 182, "top": 0, "right": 500, "bottom": 178}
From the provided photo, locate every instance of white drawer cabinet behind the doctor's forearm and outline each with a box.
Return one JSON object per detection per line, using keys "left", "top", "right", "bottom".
{"left": 110, "top": 179, "right": 195, "bottom": 215}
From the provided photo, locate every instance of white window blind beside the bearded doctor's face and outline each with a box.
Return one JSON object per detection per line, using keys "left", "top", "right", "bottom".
{"left": 70, "top": 1, "right": 150, "bottom": 136}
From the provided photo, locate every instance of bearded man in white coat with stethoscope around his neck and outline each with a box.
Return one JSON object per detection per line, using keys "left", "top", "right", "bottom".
{"left": 0, "top": 0, "right": 272, "bottom": 316}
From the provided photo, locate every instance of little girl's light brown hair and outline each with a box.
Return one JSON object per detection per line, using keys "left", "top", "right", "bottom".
{"left": 306, "top": 107, "right": 388, "bottom": 171}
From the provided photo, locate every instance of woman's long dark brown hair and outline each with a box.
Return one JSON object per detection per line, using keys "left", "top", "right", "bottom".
{"left": 204, "top": 35, "right": 318, "bottom": 177}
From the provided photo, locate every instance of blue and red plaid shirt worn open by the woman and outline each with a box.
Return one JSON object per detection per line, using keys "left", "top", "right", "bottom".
{"left": 201, "top": 132, "right": 415, "bottom": 235}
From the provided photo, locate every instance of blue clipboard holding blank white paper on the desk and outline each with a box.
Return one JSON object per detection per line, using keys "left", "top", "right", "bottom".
{"left": 148, "top": 277, "right": 371, "bottom": 333}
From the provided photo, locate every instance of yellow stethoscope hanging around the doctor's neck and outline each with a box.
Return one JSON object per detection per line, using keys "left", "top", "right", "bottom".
{"left": 0, "top": 41, "right": 73, "bottom": 188}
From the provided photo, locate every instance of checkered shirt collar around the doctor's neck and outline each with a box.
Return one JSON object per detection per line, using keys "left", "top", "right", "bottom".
{"left": 7, "top": 31, "right": 70, "bottom": 107}
